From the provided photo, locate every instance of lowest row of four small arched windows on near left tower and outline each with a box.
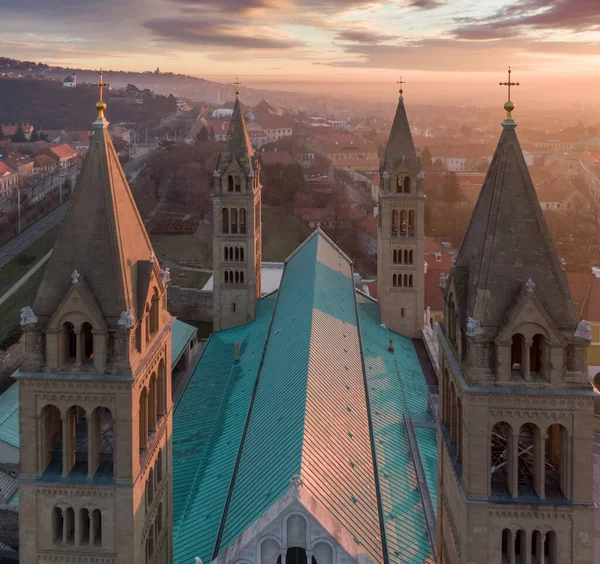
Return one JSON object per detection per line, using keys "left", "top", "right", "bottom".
{"left": 52, "top": 506, "right": 102, "bottom": 546}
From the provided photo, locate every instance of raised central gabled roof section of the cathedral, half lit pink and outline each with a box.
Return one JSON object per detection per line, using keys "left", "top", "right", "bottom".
{"left": 219, "top": 232, "right": 383, "bottom": 562}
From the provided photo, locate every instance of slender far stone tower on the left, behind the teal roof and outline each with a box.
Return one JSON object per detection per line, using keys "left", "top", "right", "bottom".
{"left": 213, "top": 83, "right": 262, "bottom": 331}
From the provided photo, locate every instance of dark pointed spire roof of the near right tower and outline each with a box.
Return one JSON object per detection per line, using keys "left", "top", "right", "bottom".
{"left": 452, "top": 120, "right": 577, "bottom": 329}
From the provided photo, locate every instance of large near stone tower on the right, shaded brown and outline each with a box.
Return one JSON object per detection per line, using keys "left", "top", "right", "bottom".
{"left": 437, "top": 98, "right": 594, "bottom": 564}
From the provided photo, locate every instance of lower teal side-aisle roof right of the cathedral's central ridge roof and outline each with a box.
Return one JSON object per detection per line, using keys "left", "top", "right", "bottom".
{"left": 358, "top": 296, "right": 437, "bottom": 564}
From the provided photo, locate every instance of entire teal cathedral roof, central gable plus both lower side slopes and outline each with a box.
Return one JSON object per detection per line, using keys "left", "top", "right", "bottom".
{"left": 173, "top": 231, "right": 436, "bottom": 564}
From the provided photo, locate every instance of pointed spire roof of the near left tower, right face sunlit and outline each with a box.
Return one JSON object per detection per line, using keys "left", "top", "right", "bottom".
{"left": 34, "top": 99, "right": 152, "bottom": 325}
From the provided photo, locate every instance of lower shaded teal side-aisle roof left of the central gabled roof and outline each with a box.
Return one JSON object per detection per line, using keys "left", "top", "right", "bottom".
{"left": 173, "top": 296, "right": 275, "bottom": 563}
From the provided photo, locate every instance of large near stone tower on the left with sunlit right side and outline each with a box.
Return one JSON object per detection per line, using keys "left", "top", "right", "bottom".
{"left": 17, "top": 91, "right": 172, "bottom": 564}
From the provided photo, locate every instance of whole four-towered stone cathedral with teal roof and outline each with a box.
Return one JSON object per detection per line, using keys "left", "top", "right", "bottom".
{"left": 11, "top": 75, "right": 594, "bottom": 564}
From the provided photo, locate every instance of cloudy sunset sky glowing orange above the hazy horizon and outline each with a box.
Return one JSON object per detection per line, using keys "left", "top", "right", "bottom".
{"left": 0, "top": 0, "right": 600, "bottom": 101}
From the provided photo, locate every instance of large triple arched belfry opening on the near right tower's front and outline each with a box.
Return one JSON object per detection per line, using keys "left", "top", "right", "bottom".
{"left": 490, "top": 421, "right": 570, "bottom": 499}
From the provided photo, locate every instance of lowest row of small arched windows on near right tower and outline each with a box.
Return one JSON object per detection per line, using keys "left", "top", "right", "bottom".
{"left": 501, "top": 529, "right": 558, "bottom": 564}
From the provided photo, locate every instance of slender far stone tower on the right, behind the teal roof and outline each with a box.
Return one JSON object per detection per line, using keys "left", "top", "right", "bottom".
{"left": 377, "top": 86, "right": 425, "bottom": 338}
